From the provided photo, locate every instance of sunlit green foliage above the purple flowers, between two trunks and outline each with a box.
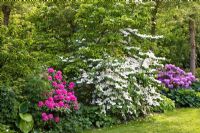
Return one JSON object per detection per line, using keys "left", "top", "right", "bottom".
{"left": 157, "top": 1, "right": 200, "bottom": 68}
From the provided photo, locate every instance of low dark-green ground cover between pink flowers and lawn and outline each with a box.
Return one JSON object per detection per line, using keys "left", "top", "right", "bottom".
{"left": 39, "top": 105, "right": 119, "bottom": 133}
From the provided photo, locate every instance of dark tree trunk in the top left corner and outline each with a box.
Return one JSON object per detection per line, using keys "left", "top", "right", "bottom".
{"left": 2, "top": 5, "right": 11, "bottom": 25}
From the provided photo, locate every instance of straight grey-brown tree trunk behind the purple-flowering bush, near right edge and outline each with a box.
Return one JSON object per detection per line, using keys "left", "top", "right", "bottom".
{"left": 189, "top": 17, "right": 196, "bottom": 75}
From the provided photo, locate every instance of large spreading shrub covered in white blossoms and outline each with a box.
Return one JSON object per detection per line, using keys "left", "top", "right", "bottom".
{"left": 62, "top": 47, "right": 162, "bottom": 119}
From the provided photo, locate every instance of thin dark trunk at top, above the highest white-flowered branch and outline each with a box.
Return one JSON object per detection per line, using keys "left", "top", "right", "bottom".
{"left": 151, "top": 0, "right": 160, "bottom": 35}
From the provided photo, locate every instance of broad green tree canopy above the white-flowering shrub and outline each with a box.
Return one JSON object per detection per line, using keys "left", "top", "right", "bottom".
{"left": 29, "top": 1, "right": 156, "bottom": 78}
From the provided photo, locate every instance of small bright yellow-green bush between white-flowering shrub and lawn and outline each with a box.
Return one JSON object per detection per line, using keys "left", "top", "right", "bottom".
{"left": 152, "top": 95, "right": 175, "bottom": 112}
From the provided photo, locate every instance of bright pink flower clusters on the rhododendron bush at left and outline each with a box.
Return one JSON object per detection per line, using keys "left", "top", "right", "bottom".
{"left": 38, "top": 68, "right": 78, "bottom": 123}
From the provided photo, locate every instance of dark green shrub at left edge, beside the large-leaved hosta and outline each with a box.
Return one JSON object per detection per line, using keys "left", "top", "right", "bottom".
{"left": 0, "top": 86, "right": 18, "bottom": 125}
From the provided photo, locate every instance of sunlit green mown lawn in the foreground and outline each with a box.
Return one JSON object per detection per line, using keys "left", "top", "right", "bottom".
{"left": 83, "top": 108, "right": 200, "bottom": 133}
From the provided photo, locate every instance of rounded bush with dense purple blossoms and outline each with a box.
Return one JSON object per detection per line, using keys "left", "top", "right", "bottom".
{"left": 157, "top": 64, "right": 196, "bottom": 89}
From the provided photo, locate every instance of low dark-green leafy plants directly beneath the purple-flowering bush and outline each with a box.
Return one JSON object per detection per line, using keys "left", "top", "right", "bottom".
{"left": 167, "top": 89, "right": 200, "bottom": 107}
